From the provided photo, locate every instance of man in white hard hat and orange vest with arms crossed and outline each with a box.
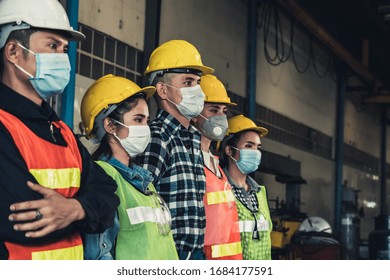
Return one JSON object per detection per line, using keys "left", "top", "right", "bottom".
{"left": 0, "top": 0, "right": 119, "bottom": 260}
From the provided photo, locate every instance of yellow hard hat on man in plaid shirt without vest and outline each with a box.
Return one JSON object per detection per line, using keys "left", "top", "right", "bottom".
{"left": 144, "top": 40, "right": 214, "bottom": 82}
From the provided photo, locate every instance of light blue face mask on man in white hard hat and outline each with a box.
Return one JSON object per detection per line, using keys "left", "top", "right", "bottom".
{"left": 15, "top": 44, "right": 70, "bottom": 99}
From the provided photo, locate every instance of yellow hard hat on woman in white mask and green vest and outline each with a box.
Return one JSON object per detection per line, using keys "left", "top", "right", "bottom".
{"left": 80, "top": 74, "right": 156, "bottom": 140}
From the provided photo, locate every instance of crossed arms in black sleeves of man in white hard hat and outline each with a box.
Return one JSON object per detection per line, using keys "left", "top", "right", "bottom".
{"left": 0, "top": 135, "right": 119, "bottom": 244}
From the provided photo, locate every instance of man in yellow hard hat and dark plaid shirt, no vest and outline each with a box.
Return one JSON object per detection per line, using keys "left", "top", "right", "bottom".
{"left": 136, "top": 40, "right": 214, "bottom": 259}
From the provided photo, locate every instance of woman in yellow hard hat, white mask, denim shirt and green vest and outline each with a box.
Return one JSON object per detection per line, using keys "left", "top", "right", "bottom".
{"left": 81, "top": 75, "right": 178, "bottom": 260}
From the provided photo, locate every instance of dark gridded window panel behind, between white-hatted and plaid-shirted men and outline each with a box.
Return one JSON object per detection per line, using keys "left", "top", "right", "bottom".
{"left": 76, "top": 23, "right": 143, "bottom": 83}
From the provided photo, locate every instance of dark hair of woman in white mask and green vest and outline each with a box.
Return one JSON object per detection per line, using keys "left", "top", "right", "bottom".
{"left": 92, "top": 93, "right": 146, "bottom": 160}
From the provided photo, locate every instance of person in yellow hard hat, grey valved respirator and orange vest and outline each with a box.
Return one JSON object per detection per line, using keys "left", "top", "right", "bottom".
{"left": 193, "top": 74, "right": 242, "bottom": 260}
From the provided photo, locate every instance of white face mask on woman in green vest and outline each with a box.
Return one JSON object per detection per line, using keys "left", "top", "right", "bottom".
{"left": 113, "top": 120, "right": 150, "bottom": 157}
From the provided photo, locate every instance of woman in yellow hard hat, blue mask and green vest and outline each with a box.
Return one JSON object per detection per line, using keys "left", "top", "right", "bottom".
{"left": 221, "top": 115, "right": 272, "bottom": 260}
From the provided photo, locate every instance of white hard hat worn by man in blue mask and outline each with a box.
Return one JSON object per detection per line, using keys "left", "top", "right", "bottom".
{"left": 0, "top": 0, "right": 85, "bottom": 48}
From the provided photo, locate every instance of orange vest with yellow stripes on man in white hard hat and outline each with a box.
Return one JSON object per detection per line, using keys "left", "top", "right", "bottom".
{"left": 0, "top": 110, "right": 83, "bottom": 260}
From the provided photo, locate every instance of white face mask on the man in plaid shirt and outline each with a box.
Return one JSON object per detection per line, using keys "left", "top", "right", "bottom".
{"left": 165, "top": 84, "right": 205, "bottom": 120}
